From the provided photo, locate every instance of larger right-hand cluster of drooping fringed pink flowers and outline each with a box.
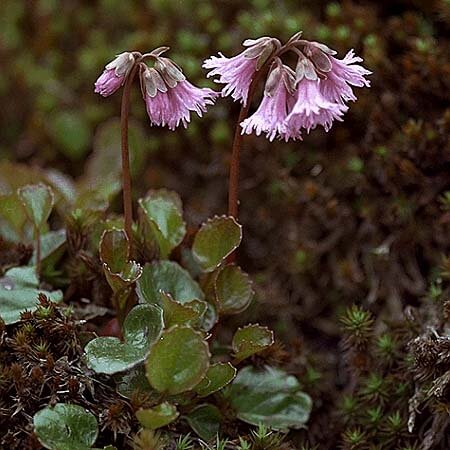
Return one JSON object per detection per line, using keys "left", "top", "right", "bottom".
{"left": 203, "top": 33, "right": 371, "bottom": 141}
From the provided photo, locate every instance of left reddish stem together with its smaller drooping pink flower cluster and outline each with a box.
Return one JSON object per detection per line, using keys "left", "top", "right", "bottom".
{"left": 95, "top": 47, "right": 218, "bottom": 248}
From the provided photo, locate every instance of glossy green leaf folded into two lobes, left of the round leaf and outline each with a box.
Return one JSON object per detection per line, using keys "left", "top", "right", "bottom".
{"left": 84, "top": 305, "right": 163, "bottom": 374}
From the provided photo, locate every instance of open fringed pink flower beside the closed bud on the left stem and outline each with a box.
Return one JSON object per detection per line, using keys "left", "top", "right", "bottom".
{"left": 141, "top": 64, "right": 218, "bottom": 130}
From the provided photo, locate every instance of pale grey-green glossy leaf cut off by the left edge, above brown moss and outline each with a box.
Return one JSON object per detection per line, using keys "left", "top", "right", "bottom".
{"left": 0, "top": 267, "right": 63, "bottom": 325}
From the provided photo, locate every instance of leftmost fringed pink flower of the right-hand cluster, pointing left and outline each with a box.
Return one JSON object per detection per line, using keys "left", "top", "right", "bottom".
{"left": 203, "top": 37, "right": 280, "bottom": 106}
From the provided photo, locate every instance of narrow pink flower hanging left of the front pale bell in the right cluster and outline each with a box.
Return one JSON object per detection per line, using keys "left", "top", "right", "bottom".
{"left": 241, "top": 63, "right": 301, "bottom": 141}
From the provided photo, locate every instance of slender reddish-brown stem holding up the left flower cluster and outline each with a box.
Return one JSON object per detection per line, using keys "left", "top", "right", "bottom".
{"left": 120, "top": 64, "right": 138, "bottom": 244}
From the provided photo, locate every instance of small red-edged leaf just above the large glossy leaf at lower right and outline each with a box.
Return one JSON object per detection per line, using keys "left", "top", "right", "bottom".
{"left": 232, "top": 325, "right": 273, "bottom": 362}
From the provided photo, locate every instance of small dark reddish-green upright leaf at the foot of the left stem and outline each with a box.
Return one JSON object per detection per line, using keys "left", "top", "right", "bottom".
{"left": 100, "top": 228, "right": 130, "bottom": 273}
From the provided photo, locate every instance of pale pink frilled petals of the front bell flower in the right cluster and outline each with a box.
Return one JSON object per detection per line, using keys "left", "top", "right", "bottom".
{"left": 283, "top": 78, "right": 348, "bottom": 135}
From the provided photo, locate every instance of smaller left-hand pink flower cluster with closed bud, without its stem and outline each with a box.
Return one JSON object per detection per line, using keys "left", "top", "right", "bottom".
{"left": 95, "top": 47, "right": 218, "bottom": 130}
